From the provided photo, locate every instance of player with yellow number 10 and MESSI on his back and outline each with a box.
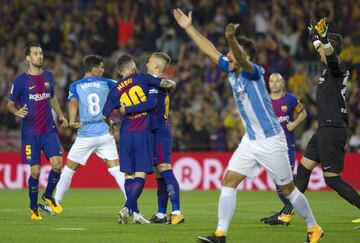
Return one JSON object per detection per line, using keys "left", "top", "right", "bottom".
{"left": 103, "top": 55, "right": 175, "bottom": 224}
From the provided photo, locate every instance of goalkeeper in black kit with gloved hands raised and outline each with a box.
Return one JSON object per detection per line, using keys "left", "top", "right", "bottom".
{"left": 263, "top": 18, "right": 360, "bottom": 228}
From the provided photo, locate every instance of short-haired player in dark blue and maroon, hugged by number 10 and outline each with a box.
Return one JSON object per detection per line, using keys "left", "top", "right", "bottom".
{"left": 119, "top": 52, "right": 185, "bottom": 224}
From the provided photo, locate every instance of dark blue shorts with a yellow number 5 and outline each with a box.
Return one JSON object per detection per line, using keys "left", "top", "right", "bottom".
{"left": 21, "top": 132, "right": 62, "bottom": 165}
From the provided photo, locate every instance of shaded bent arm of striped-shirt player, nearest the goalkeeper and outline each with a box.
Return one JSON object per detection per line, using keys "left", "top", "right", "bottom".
{"left": 225, "top": 23, "right": 253, "bottom": 73}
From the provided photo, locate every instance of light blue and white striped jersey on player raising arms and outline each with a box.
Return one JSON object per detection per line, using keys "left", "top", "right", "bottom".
{"left": 218, "top": 56, "right": 281, "bottom": 140}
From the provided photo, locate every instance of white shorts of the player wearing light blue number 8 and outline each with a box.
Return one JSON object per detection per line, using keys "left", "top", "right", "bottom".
{"left": 68, "top": 133, "right": 119, "bottom": 165}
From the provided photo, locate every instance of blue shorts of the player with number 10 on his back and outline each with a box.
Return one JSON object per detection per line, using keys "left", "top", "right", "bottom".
{"left": 119, "top": 131, "right": 153, "bottom": 174}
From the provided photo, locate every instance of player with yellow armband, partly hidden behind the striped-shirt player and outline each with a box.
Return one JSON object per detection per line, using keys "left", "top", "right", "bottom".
{"left": 261, "top": 73, "right": 307, "bottom": 225}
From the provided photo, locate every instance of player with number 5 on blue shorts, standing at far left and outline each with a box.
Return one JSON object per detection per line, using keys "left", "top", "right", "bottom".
{"left": 7, "top": 43, "right": 68, "bottom": 220}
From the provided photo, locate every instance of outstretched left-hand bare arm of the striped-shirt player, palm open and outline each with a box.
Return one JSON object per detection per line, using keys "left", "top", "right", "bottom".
{"left": 173, "top": 8, "right": 221, "bottom": 64}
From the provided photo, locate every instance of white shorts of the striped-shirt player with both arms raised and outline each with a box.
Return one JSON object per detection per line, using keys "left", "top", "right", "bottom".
{"left": 227, "top": 131, "right": 293, "bottom": 185}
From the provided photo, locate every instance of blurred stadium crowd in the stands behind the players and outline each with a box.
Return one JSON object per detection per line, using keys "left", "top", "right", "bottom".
{"left": 0, "top": 0, "right": 360, "bottom": 152}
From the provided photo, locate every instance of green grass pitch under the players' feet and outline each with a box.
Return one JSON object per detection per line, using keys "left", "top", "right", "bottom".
{"left": 0, "top": 189, "right": 360, "bottom": 243}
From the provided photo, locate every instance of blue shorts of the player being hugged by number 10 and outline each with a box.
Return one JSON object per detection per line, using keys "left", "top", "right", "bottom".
{"left": 153, "top": 126, "right": 172, "bottom": 166}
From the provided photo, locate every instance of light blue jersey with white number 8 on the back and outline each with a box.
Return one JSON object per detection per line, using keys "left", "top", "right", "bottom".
{"left": 68, "top": 77, "right": 116, "bottom": 137}
